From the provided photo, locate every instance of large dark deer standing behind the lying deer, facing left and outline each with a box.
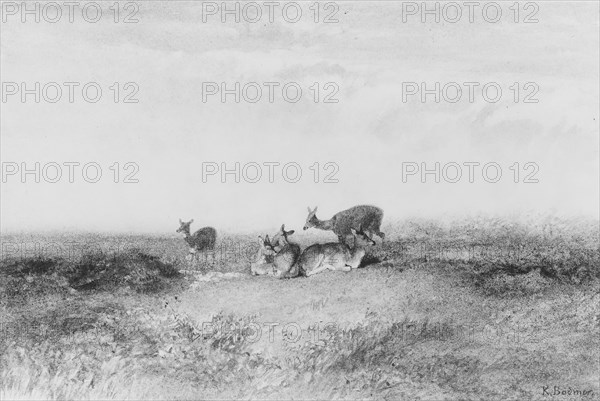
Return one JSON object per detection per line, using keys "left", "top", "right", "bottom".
{"left": 304, "top": 205, "right": 385, "bottom": 244}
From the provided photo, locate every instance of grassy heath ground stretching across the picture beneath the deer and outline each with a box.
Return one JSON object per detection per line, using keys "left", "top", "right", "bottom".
{"left": 0, "top": 218, "right": 600, "bottom": 400}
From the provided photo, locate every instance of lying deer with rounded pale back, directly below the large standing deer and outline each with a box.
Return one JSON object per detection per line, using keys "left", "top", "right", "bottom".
{"left": 298, "top": 226, "right": 375, "bottom": 277}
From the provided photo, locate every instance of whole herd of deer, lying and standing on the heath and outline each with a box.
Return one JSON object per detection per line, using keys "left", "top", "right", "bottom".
{"left": 177, "top": 205, "right": 385, "bottom": 278}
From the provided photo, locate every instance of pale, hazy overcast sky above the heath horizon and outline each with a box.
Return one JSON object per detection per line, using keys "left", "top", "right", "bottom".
{"left": 1, "top": 1, "right": 600, "bottom": 233}
